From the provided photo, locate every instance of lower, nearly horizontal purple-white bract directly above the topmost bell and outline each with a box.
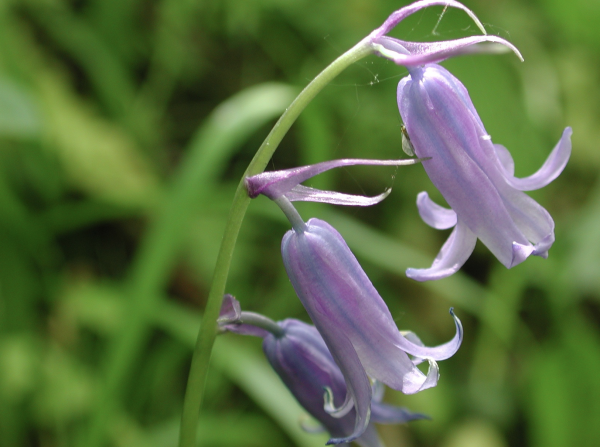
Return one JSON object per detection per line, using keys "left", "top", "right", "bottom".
{"left": 371, "top": 35, "right": 523, "bottom": 67}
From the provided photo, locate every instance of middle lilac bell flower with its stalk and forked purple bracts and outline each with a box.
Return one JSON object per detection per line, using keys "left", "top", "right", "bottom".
{"left": 246, "top": 160, "right": 462, "bottom": 442}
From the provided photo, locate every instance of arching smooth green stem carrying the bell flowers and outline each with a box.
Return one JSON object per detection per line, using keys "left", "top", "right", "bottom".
{"left": 179, "top": 39, "right": 373, "bottom": 447}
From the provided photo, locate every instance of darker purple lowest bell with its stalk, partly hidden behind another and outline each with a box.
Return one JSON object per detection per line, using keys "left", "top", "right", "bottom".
{"left": 218, "top": 295, "right": 427, "bottom": 447}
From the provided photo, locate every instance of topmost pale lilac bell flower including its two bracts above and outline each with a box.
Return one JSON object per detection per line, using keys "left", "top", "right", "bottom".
{"left": 360, "top": 0, "right": 572, "bottom": 281}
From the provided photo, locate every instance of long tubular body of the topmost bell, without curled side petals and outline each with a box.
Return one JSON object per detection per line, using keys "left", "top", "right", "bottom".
{"left": 398, "top": 64, "right": 529, "bottom": 268}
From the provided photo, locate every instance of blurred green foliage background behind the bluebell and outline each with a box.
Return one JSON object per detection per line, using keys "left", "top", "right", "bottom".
{"left": 0, "top": 0, "right": 600, "bottom": 447}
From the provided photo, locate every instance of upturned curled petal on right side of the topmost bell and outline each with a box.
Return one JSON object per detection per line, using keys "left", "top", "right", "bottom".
{"left": 496, "top": 127, "right": 573, "bottom": 191}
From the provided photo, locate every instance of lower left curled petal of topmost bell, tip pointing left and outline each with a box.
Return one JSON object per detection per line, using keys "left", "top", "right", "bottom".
{"left": 406, "top": 220, "right": 477, "bottom": 281}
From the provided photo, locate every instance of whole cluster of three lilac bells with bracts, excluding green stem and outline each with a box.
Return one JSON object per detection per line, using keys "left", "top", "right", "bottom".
{"left": 219, "top": 0, "right": 572, "bottom": 446}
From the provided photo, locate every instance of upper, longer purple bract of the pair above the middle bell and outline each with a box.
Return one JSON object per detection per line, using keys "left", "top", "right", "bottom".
{"left": 244, "top": 159, "right": 421, "bottom": 203}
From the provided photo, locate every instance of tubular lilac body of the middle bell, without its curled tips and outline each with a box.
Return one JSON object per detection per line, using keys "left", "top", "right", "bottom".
{"left": 281, "top": 219, "right": 454, "bottom": 393}
